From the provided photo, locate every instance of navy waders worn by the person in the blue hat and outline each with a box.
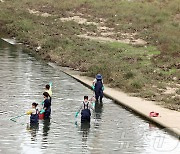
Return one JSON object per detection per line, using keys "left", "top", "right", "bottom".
{"left": 94, "top": 80, "right": 103, "bottom": 102}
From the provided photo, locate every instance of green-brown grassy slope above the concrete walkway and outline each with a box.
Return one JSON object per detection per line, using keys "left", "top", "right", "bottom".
{"left": 0, "top": 0, "right": 180, "bottom": 110}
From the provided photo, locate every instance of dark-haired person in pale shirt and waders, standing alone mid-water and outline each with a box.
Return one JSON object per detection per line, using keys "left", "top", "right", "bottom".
{"left": 75, "top": 96, "right": 94, "bottom": 123}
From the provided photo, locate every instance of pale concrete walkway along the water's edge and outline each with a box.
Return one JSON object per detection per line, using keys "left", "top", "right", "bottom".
{"left": 50, "top": 63, "right": 180, "bottom": 139}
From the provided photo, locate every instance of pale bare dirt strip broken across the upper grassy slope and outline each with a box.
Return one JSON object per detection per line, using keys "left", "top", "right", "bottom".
{"left": 28, "top": 9, "right": 147, "bottom": 46}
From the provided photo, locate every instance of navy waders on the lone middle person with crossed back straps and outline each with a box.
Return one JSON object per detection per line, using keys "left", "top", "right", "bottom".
{"left": 81, "top": 102, "right": 91, "bottom": 123}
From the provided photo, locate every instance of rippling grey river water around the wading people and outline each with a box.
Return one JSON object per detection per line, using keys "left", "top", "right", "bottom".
{"left": 0, "top": 38, "right": 180, "bottom": 154}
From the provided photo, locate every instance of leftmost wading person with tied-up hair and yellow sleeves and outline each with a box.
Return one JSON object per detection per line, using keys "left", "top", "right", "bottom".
{"left": 26, "top": 103, "right": 39, "bottom": 124}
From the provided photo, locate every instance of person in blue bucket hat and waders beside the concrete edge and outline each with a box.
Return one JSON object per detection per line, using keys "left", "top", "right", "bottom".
{"left": 92, "top": 74, "right": 104, "bottom": 102}
